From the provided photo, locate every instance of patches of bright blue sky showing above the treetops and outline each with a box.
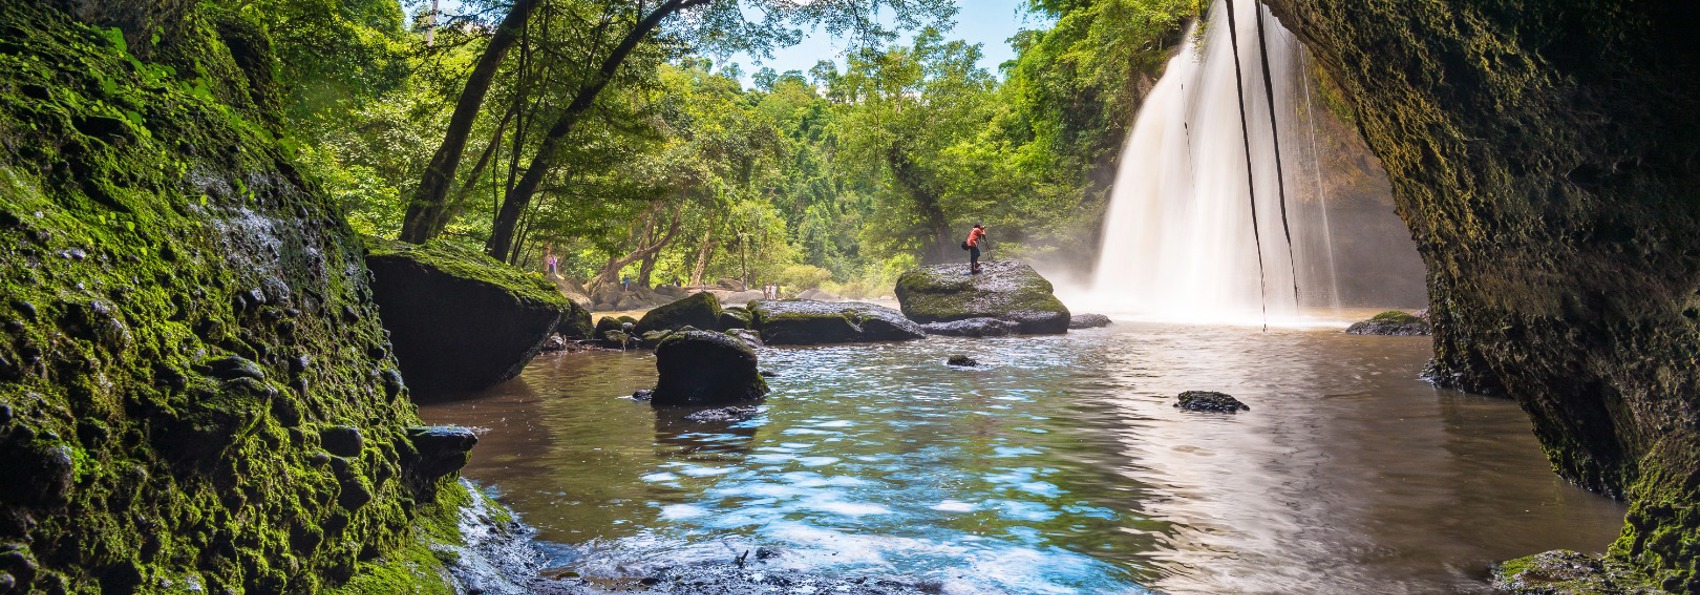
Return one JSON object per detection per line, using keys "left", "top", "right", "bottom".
{"left": 731, "top": 0, "right": 1046, "bottom": 83}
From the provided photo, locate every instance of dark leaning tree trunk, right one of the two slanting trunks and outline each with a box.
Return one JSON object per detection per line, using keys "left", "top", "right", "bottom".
{"left": 485, "top": 0, "right": 712, "bottom": 255}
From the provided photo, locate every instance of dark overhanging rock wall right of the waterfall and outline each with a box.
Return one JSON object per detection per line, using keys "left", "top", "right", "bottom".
{"left": 1273, "top": 0, "right": 1700, "bottom": 584}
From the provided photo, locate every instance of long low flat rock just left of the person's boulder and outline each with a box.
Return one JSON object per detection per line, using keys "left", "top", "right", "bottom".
{"left": 750, "top": 299, "right": 927, "bottom": 345}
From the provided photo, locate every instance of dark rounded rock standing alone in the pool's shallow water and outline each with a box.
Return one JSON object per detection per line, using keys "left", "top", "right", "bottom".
{"left": 651, "top": 330, "right": 767, "bottom": 406}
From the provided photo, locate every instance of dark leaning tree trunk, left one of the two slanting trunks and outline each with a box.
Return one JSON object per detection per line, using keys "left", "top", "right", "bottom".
{"left": 401, "top": 0, "right": 539, "bottom": 243}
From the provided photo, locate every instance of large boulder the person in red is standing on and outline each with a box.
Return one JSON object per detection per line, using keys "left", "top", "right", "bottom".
{"left": 898, "top": 260, "right": 1069, "bottom": 335}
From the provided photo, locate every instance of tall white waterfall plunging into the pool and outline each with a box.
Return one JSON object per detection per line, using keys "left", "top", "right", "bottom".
{"left": 1093, "top": 2, "right": 1338, "bottom": 321}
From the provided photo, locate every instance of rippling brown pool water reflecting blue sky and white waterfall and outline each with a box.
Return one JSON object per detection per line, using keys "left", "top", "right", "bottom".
{"left": 422, "top": 323, "right": 1624, "bottom": 593}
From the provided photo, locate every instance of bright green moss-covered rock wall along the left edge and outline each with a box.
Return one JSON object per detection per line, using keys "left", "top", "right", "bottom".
{"left": 0, "top": 0, "right": 459, "bottom": 593}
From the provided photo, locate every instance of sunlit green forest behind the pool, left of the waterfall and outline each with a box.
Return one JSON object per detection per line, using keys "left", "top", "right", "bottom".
{"left": 278, "top": 0, "right": 1200, "bottom": 298}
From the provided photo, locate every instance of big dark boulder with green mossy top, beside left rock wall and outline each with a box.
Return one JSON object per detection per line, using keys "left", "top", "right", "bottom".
{"left": 366, "top": 240, "right": 576, "bottom": 400}
